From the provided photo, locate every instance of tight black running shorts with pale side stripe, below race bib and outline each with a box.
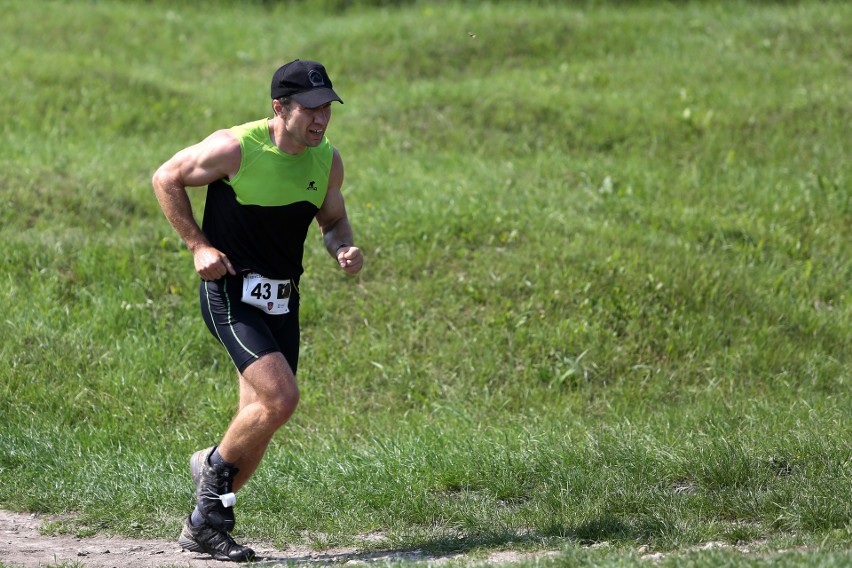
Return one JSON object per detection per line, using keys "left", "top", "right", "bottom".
{"left": 199, "top": 275, "right": 299, "bottom": 374}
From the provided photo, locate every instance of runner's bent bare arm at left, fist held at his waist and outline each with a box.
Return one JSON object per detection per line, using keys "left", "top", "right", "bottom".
{"left": 151, "top": 130, "right": 241, "bottom": 280}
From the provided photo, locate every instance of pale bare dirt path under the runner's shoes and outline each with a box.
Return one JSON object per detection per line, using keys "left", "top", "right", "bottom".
{"left": 0, "top": 511, "right": 541, "bottom": 568}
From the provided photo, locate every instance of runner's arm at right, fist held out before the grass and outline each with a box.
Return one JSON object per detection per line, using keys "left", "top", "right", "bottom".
{"left": 317, "top": 149, "right": 364, "bottom": 274}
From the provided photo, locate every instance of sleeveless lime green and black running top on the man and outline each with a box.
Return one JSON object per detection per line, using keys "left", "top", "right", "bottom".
{"left": 202, "top": 119, "right": 334, "bottom": 280}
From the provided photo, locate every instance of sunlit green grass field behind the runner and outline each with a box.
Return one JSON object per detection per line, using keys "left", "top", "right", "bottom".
{"left": 0, "top": 0, "right": 852, "bottom": 566}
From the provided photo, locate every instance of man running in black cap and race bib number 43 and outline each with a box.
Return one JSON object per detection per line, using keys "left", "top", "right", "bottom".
{"left": 152, "top": 59, "right": 363, "bottom": 561}
